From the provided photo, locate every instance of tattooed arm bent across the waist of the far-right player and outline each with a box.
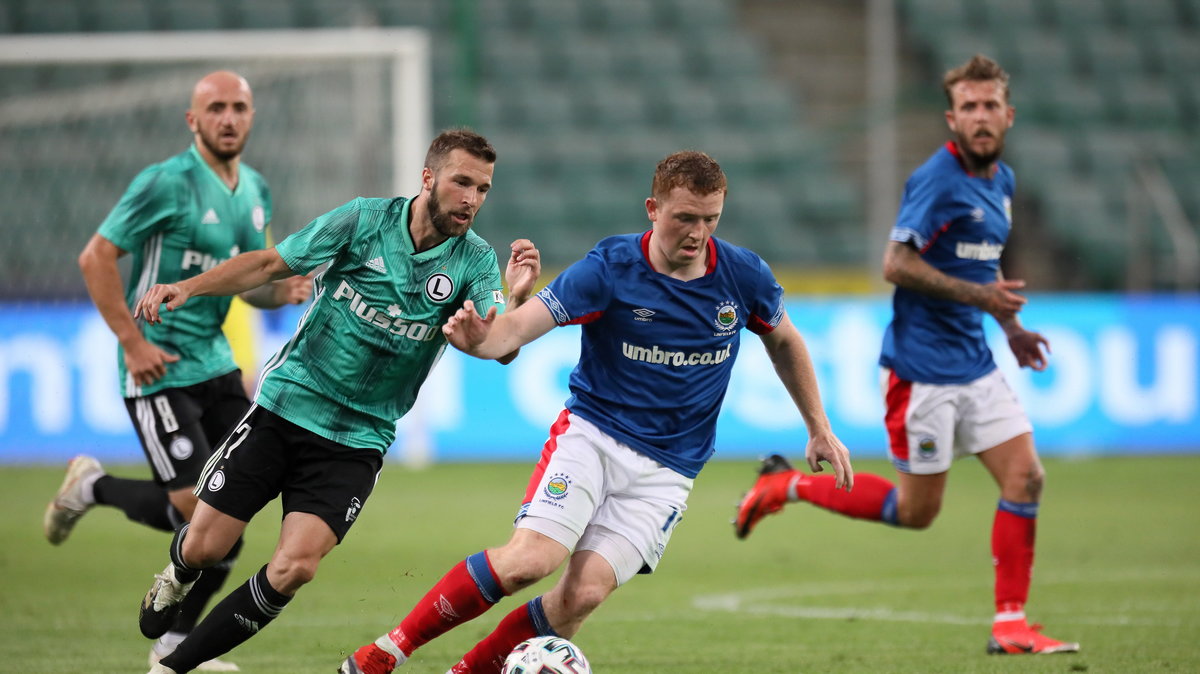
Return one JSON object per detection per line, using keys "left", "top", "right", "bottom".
{"left": 883, "top": 241, "right": 1026, "bottom": 323}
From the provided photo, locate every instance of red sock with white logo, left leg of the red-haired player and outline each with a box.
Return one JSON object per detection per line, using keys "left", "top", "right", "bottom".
{"left": 388, "top": 552, "right": 505, "bottom": 655}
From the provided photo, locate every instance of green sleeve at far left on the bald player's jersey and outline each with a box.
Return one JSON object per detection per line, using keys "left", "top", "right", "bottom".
{"left": 97, "top": 168, "right": 180, "bottom": 251}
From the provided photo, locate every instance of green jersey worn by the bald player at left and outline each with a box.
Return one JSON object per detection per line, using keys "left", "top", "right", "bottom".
{"left": 98, "top": 145, "right": 271, "bottom": 398}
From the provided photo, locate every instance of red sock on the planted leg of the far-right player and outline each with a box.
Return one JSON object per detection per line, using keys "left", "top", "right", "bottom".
{"left": 991, "top": 500, "right": 1038, "bottom": 613}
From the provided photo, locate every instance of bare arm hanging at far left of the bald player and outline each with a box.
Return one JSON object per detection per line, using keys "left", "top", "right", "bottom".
{"left": 79, "top": 234, "right": 179, "bottom": 386}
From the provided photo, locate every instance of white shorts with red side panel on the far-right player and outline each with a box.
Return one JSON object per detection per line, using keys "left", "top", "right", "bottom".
{"left": 880, "top": 368, "right": 1033, "bottom": 475}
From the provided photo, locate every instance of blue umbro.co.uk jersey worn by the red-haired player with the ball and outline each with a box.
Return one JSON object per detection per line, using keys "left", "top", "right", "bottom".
{"left": 538, "top": 231, "right": 784, "bottom": 477}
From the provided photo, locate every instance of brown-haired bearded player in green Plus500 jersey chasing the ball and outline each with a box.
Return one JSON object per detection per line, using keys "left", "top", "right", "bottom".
{"left": 136, "top": 130, "right": 541, "bottom": 674}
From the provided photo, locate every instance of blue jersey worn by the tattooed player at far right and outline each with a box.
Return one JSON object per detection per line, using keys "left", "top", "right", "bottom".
{"left": 880, "top": 143, "right": 1014, "bottom": 384}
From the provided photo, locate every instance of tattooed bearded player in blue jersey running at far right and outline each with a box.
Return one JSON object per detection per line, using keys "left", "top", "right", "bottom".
{"left": 734, "top": 55, "right": 1079, "bottom": 654}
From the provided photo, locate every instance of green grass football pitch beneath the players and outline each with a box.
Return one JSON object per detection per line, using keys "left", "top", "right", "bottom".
{"left": 0, "top": 456, "right": 1200, "bottom": 674}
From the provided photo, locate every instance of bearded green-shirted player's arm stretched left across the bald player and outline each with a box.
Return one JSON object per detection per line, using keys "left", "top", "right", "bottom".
{"left": 133, "top": 248, "right": 295, "bottom": 323}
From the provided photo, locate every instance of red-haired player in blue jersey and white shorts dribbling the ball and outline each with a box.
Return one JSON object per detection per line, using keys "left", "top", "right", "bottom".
{"left": 341, "top": 152, "right": 853, "bottom": 674}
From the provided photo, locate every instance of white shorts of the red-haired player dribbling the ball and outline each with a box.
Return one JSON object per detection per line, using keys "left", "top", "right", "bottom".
{"left": 516, "top": 410, "right": 694, "bottom": 584}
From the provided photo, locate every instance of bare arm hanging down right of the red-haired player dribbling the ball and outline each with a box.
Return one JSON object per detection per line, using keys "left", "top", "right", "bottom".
{"left": 762, "top": 313, "right": 854, "bottom": 492}
